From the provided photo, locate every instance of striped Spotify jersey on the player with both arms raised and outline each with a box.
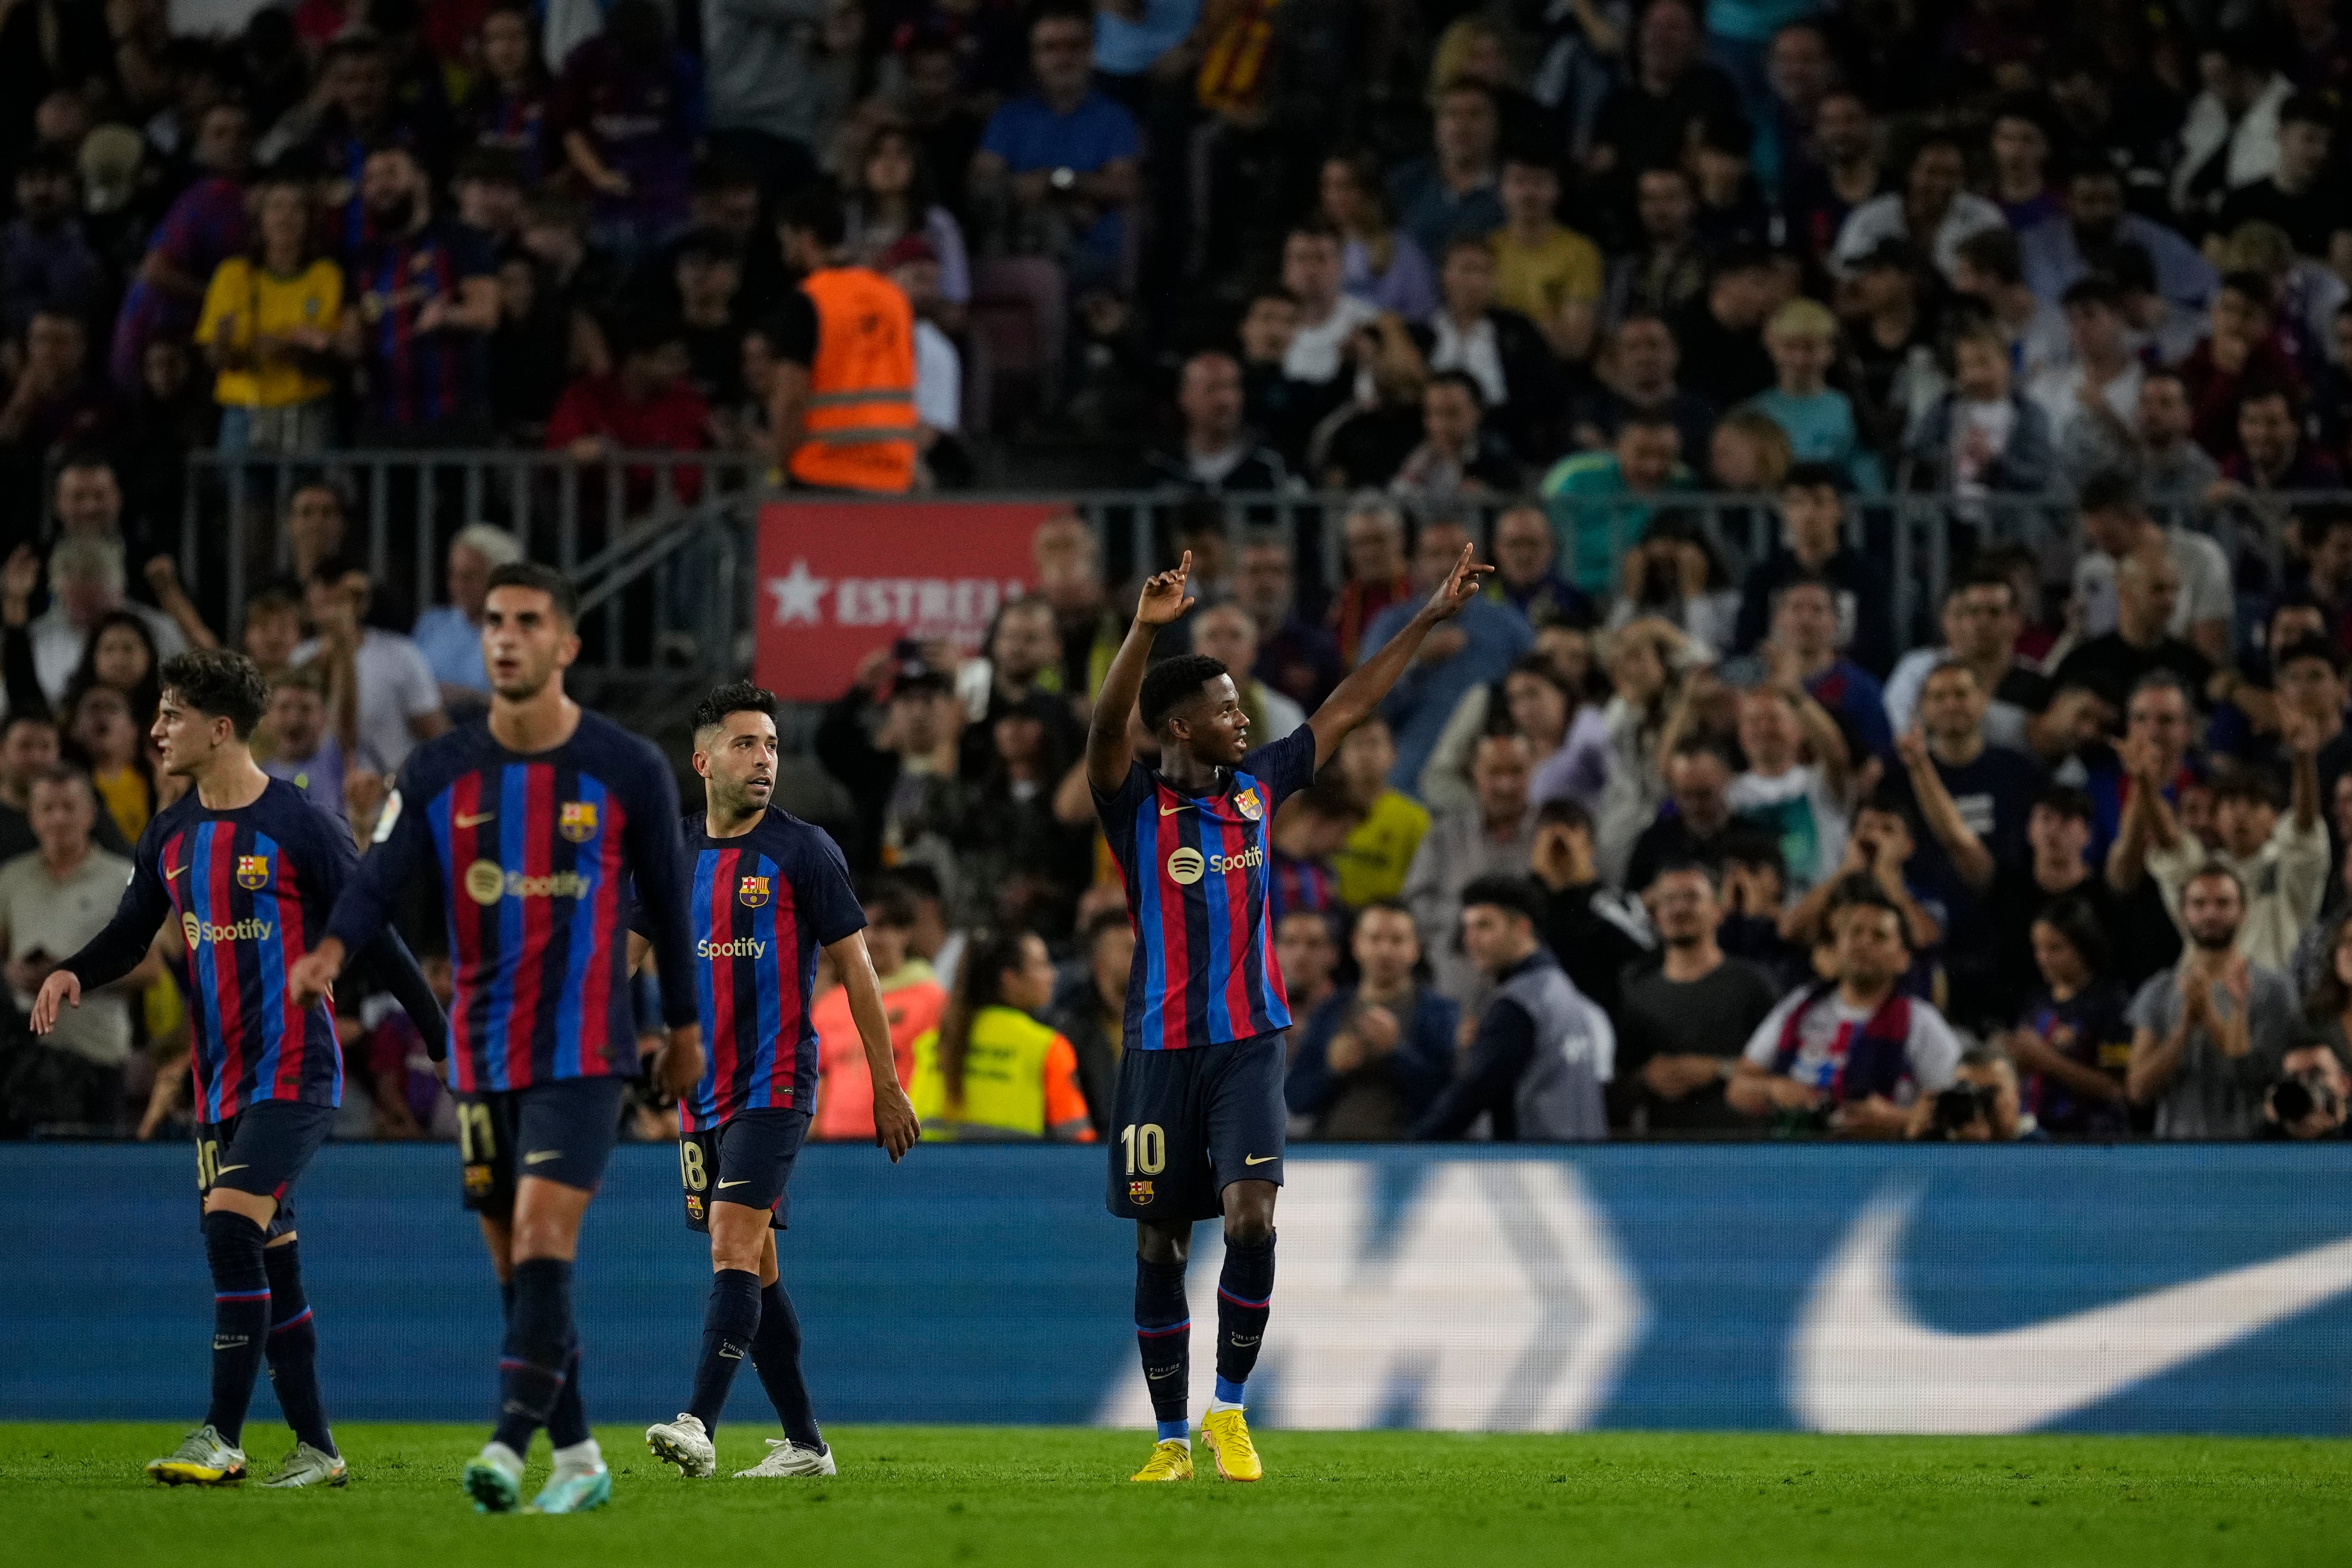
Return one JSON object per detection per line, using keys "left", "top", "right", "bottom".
{"left": 1094, "top": 727, "right": 1315, "bottom": 1051}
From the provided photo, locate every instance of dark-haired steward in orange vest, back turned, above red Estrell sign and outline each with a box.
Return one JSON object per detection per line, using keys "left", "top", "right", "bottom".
{"left": 774, "top": 188, "right": 915, "bottom": 494}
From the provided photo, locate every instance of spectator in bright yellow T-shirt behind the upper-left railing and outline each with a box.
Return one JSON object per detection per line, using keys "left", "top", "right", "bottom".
{"left": 195, "top": 176, "right": 343, "bottom": 454}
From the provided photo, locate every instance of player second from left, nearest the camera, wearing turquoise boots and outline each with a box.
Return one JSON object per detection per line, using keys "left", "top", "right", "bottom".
{"left": 294, "top": 562, "right": 703, "bottom": 1514}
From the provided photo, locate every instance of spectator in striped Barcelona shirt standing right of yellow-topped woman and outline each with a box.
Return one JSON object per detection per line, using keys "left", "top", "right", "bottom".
{"left": 339, "top": 146, "right": 499, "bottom": 447}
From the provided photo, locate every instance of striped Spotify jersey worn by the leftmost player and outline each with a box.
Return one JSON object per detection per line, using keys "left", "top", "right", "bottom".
{"left": 66, "top": 778, "right": 440, "bottom": 1121}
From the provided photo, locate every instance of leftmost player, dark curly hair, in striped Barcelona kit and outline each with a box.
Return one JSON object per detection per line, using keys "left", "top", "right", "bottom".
{"left": 33, "top": 649, "right": 442, "bottom": 1486}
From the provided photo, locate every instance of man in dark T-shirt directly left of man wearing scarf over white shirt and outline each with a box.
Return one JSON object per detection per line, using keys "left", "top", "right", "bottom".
{"left": 1611, "top": 863, "right": 1780, "bottom": 1133}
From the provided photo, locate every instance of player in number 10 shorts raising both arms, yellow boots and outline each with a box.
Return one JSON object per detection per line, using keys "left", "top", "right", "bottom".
{"left": 1087, "top": 546, "right": 1494, "bottom": 1481}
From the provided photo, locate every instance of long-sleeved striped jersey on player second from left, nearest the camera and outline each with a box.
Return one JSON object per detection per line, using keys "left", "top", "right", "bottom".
{"left": 327, "top": 713, "right": 694, "bottom": 1093}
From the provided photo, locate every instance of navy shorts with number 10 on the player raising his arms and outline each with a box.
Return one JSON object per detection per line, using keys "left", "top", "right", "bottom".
{"left": 1110, "top": 1029, "right": 1289, "bottom": 1222}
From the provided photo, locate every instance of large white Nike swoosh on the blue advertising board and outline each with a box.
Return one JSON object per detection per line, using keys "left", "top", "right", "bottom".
{"left": 1788, "top": 1194, "right": 2352, "bottom": 1434}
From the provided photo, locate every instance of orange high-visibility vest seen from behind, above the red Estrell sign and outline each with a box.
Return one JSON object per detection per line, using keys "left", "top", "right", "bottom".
{"left": 793, "top": 266, "right": 915, "bottom": 491}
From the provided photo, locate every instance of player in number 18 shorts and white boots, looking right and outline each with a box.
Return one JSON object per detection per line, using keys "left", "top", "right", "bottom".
{"left": 630, "top": 682, "right": 920, "bottom": 1479}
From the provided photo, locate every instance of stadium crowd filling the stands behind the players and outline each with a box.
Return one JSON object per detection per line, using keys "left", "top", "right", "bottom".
{"left": 0, "top": 0, "right": 2352, "bottom": 1138}
